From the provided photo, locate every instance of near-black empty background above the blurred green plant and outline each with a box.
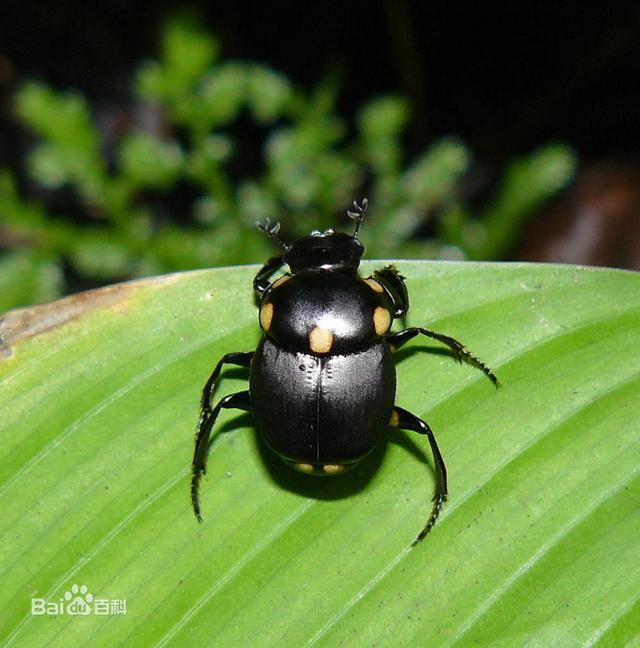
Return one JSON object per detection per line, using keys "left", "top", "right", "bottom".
{"left": 0, "top": 0, "right": 640, "bottom": 267}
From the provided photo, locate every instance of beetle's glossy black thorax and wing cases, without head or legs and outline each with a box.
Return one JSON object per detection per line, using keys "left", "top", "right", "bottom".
{"left": 249, "top": 270, "right": 396, "bottom": 474}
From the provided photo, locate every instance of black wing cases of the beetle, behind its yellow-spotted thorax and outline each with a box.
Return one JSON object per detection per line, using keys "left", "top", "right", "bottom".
{"left": 250, "top": 337, "right": 396, "bottom": 465}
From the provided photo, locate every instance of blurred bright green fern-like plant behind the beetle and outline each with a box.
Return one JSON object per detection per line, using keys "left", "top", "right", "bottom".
{"left": 0, "top": 13, "right": 575, "bottom": 310}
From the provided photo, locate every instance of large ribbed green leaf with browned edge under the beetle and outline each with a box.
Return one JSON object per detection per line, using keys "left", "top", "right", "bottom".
{"left": 0, "top": 261, "right": 640, "bottom": 646}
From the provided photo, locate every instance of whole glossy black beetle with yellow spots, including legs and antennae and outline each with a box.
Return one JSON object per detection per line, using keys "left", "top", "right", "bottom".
{"left": 191, "top": 199, "right": 499, "bottom": 544}
